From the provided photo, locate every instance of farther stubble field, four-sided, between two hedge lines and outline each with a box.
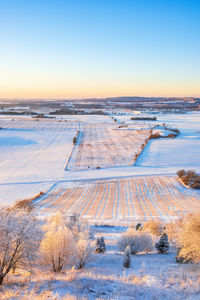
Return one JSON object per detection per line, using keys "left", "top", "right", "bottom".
{"left": 68, "top": 123, "right": 150, "bottom": 170}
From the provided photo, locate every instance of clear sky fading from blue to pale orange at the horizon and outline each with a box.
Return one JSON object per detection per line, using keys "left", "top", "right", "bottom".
{"left": 0, "top": 0, "right": 200, "bottom": 99}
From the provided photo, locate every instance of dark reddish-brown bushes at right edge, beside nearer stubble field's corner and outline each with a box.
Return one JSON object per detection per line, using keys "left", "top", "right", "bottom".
{"left": 177, "top": 170, "right": 200, "bottom": 189}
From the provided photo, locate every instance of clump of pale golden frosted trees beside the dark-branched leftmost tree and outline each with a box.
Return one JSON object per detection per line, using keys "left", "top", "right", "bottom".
{"left": 40, "top": 213, "right": 94, "bottom": 272}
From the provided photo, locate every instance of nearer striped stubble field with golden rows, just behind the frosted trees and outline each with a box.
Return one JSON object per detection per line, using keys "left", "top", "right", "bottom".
{"left": 36, "top": 176, "right": 200, "bottom": 223}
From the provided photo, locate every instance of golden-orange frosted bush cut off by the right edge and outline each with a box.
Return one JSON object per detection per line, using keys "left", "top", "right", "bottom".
{"left": 177, "top": 213, "right": 200, "bottom": 263}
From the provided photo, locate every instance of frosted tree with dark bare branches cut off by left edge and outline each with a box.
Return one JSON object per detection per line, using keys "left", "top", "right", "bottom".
{"left": 0, "top": 209, "right": 42, "bottom": 284}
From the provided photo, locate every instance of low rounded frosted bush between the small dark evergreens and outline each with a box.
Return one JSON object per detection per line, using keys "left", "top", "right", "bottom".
{"left": 118, "top": 229, "right": 153, "bottom": 254}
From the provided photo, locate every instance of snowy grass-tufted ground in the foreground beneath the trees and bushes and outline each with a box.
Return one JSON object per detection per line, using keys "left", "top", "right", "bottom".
{"left": 0, "top": 227, "right": 200, "bottom": 300}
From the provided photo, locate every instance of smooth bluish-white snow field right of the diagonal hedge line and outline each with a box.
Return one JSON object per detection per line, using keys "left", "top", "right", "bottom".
{"left": 137, "top": 112, "right": 200, "bottom": 171}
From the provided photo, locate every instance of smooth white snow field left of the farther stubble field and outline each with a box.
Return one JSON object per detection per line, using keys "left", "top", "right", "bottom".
{"left": 0, "top": 118, "right": 77, "bottom": 205}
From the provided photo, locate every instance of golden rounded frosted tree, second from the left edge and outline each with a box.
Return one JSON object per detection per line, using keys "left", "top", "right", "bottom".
{"left": 40, "top": 222, "right": 76, "bottom": 272}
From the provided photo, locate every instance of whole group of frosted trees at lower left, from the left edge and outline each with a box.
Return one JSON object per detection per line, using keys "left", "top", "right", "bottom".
{"left": 0, "top": 208, "right": 95, "bottom": 285}
